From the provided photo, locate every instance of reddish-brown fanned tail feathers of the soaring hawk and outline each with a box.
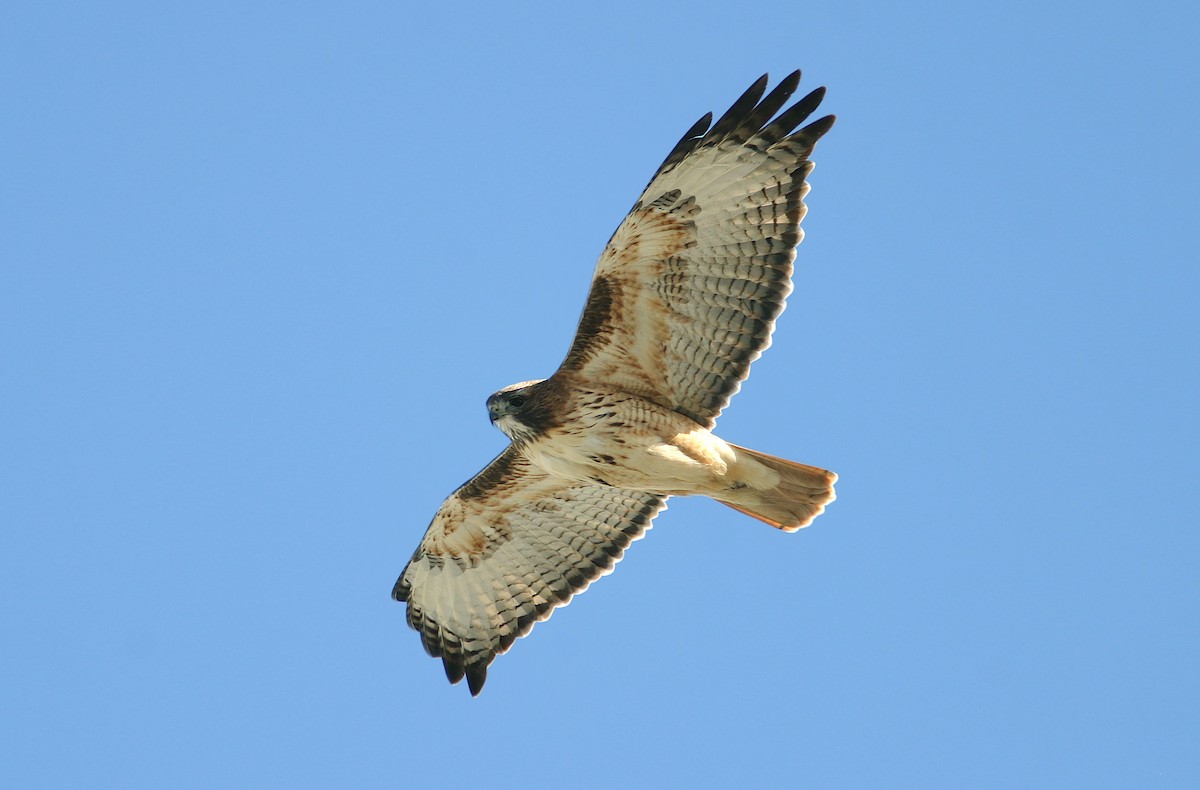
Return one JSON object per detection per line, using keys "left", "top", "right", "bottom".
{"left": 713, "top": 444, "right": 838, "bottom": 532}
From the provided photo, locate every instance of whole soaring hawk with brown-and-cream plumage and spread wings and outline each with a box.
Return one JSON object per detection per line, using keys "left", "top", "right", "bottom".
{"left": 392, "top": 71, "right": 838, "bottom": 695}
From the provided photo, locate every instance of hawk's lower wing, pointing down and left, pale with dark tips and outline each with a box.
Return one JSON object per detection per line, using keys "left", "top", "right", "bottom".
{"left": 392, "top": 447, "right": 666, "bottom": 695}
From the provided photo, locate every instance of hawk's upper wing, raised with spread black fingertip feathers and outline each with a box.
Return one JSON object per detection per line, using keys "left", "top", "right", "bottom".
{"left": 558, "top": 71, "right": 834, "bottom": 427}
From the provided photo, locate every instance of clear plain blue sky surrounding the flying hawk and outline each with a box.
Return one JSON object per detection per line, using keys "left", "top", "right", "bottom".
{"left": 0, "top": 2, "right": 1200, "bottom": 788}
